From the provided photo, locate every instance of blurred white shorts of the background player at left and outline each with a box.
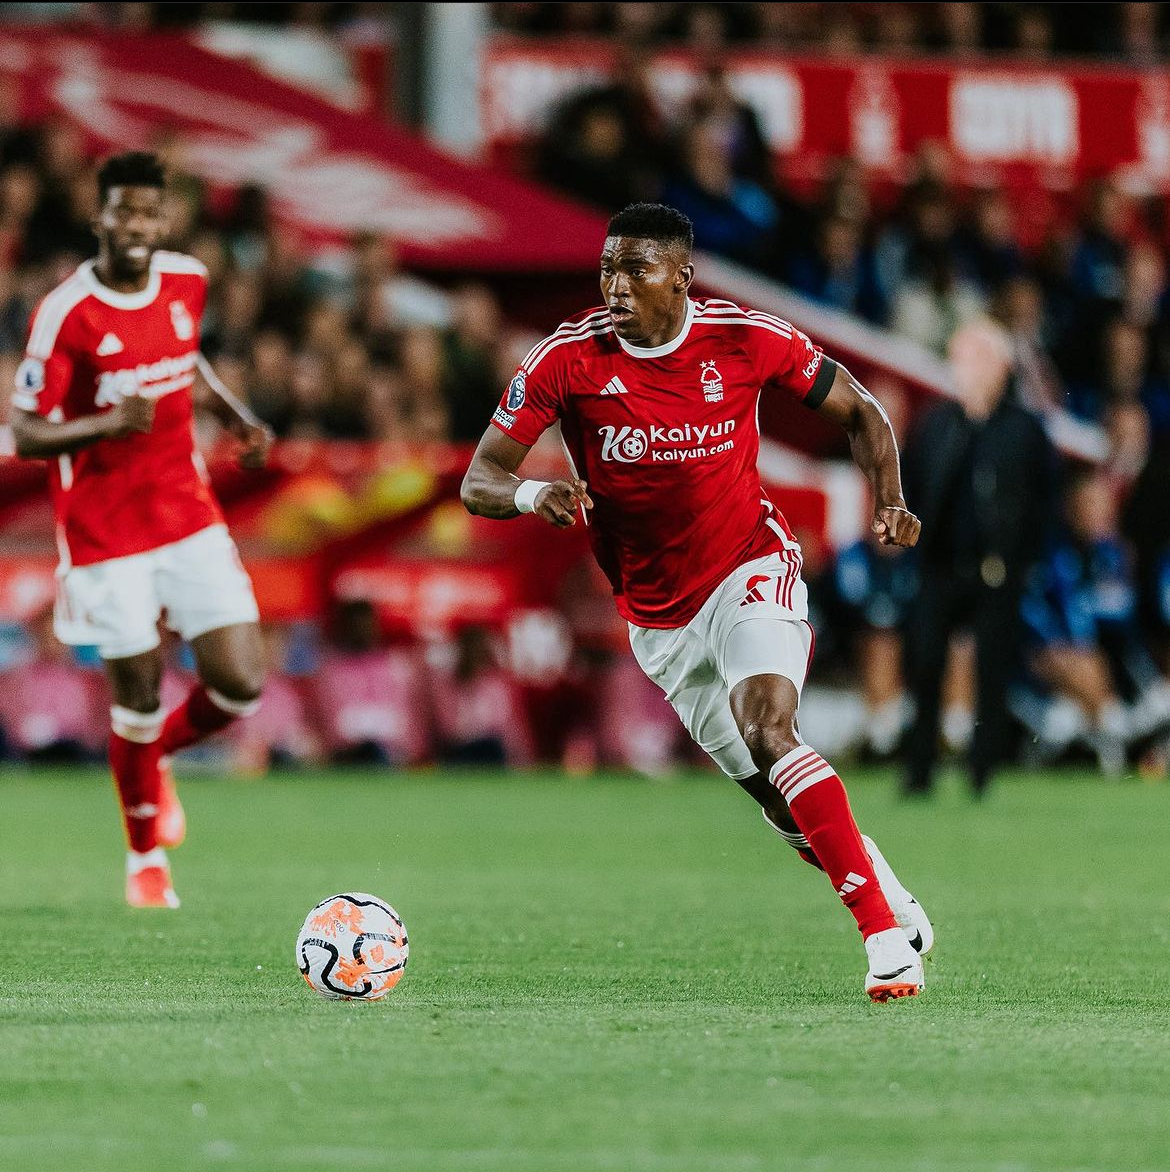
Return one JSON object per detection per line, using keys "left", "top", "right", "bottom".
{"left": 54, "top": 525, "right": 259, "bottom": 659}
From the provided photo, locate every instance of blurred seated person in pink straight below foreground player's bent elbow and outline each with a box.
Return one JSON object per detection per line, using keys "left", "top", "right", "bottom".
{"left": 431, "top": 625, "right": 532, "bottom": 768}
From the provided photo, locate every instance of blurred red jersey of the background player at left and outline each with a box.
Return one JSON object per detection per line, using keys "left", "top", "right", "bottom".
{"left": 12, "top": 252, "right": 223, "bottom": 566}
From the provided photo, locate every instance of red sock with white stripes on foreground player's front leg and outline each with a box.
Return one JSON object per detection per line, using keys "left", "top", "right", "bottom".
{"left": 768, "top": 744, "right": 898, "bottom": 938}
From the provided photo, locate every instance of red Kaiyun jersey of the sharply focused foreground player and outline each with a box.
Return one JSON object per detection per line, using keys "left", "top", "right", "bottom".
{"left": 492, "top": 299, "right": 836, "bottom": 627}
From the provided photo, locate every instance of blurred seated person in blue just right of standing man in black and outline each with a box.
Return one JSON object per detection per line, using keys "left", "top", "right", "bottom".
{"left": 1013, "top": 469, "right": 1170, "bottom": 775}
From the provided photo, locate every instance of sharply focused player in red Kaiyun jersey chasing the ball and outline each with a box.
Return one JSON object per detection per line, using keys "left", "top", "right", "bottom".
{"left": 462, "top": 204, "right": 933, "bottom": 1001}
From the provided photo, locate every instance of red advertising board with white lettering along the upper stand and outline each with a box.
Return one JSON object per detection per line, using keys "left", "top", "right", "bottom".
{"left": 479, "top": 39, "right": 1170, "bottom": 191}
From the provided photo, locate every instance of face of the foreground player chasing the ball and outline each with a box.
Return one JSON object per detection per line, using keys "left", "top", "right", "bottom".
{"left": 601, "top": 236, "right": 692, "bottom": 346}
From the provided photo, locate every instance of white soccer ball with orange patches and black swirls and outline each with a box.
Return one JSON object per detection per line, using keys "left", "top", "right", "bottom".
{"left": 297, "top": 892, "right": 410, "bottom": 1001}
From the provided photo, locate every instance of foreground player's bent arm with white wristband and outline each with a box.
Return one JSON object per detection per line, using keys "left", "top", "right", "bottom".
{"left": 460, "top": 427, "right": 593, "bottom": 529}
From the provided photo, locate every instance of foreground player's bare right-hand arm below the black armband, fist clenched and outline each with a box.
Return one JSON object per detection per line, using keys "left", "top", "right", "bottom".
{"left": 817, "top": 363, "right": 923, "bottom": 547}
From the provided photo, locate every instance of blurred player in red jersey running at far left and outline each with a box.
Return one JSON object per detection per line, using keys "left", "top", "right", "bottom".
{"left": 12, "top": 152, "right": 272, "bottom": 907}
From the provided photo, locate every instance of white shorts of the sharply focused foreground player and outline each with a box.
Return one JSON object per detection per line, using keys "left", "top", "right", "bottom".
{"left": 630, "top": 551, "right": 812, "bottom": 781}
